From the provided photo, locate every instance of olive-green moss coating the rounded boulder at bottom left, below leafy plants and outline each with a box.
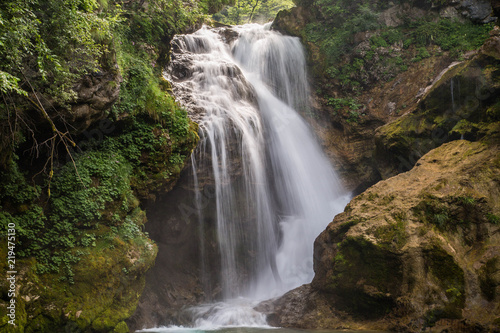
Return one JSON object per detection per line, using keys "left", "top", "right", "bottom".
{"left": 18, "top": 228, "right": 157, "bottom": 332}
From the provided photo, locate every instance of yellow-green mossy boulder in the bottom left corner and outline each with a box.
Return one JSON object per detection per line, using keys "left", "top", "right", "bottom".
{"left": 0, "top": 209, "right": 157, "bottom": 332}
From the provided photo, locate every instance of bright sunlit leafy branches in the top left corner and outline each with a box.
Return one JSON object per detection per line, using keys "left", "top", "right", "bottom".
{"left": 0, "top": 0, "right": 111, "bottom": 104}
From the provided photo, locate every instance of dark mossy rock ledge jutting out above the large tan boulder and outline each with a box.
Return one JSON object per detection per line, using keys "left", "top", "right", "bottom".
{"left": 375, "top": 30, "right": 500, "bottom": 178}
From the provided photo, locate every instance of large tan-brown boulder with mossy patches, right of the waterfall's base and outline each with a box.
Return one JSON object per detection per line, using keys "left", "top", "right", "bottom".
{"left": 268, "top": 136, "right": 500, "bottom": 332}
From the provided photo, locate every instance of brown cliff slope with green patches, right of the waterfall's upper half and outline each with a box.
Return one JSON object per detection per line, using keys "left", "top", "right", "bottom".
{"left": 273, "top": 1, "right": 496, "bottom": 193}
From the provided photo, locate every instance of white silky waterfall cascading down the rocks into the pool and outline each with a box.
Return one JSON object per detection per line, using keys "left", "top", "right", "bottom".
{"left": 150, "top": 24, "right": 349, "bottom": 331}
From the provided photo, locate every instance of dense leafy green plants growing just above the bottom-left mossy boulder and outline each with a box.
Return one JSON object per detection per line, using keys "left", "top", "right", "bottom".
{"left": 0, "top": 147, "right": 151, "bottom": 283}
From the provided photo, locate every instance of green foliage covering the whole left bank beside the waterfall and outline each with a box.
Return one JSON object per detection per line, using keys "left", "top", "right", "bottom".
{"left": 0, "top": 0, "right": 199, "bottom": 331}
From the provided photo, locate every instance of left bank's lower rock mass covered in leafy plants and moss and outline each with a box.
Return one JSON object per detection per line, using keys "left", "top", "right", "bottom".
{"left": 0, "top": 107, "right": 198, "bottom": 332}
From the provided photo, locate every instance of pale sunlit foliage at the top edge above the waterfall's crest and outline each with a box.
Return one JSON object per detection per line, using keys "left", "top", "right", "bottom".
{"left": 213, "top": 0, "right": 294, "bottom": 24}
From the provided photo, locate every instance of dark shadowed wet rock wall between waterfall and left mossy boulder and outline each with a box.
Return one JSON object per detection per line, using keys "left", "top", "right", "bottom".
{"left": 127, "top": 174, "right": 221, "bottom": 331}
